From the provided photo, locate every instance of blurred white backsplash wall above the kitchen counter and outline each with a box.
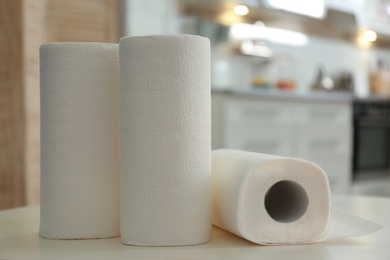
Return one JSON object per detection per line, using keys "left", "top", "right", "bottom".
{"left": 212, "top": 33, "right": 380, "bottom": 95}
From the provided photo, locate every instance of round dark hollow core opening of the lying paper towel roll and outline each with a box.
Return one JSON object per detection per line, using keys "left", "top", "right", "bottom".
{"left": 264, "top": 180, "right": 309, "bottom": 223}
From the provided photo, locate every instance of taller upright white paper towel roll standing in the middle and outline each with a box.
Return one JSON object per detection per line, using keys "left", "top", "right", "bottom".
{"left": 119, "top": 35, "right": 211, "bottom": 246}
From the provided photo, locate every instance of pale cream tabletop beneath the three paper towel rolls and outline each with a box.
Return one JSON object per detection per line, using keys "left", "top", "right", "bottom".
{"left": 0, "top": 196, "right": 390, "bottom": 260}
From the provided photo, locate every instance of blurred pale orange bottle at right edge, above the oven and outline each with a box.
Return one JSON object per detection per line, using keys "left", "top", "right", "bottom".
{"left": 370, "top": 58, "right": 390, "bottom": 97}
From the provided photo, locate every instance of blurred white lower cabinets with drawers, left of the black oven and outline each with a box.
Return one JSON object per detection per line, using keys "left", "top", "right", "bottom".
{"left": 212, "top": 91, "right": 352, "bottom": 194}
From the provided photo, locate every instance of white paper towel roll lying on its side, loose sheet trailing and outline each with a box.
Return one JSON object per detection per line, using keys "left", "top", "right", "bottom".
{"left": 212, "top": 150, "right": 380, "bottom": 244}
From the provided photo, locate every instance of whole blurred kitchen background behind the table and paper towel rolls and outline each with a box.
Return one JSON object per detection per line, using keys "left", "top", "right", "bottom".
{"left": 0, "top": 0, "right": 390, "bottom": 209}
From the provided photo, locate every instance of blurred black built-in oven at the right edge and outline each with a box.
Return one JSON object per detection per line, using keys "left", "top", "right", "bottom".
{"left": 353, "top": 100, "right": 390, "bottom": 179}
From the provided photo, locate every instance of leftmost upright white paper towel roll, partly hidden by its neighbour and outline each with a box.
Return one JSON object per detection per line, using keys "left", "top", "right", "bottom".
{"left": 40, "top": 43, "right": 119, "bottom": 239}
